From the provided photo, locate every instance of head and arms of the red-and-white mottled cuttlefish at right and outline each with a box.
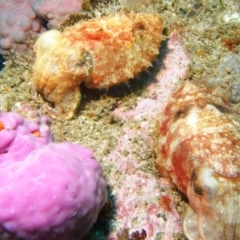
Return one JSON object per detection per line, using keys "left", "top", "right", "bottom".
{"left": 183, "top": 166, "right": 240, "bottom": 240}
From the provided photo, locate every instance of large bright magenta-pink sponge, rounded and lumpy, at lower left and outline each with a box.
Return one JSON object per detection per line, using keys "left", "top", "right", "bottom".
{"left": 0, "top": 112, "right": 107, "bottom": 240}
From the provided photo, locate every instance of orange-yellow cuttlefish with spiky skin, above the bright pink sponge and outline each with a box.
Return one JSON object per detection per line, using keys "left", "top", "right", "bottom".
{"left": 32, "top": 13, "right": 164, "bottom": 119}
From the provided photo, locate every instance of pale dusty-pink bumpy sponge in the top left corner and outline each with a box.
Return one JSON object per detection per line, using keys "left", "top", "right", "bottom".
{"left": 0, "top": 0, "right": 82, "bottom": 56}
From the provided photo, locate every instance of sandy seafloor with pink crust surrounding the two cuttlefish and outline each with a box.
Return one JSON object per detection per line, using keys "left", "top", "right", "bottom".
{"left": 0, "top": 0, "right": 240, "bottom": 240}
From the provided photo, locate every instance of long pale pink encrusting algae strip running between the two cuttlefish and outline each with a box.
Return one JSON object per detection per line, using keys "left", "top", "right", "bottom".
{"left": 102, "top": 35, "right": 188, "bottom": 240}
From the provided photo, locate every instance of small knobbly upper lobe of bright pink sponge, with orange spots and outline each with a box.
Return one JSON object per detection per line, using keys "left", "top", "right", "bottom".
{"left": 0, "top": 112, "right": 53, "bottom": 163}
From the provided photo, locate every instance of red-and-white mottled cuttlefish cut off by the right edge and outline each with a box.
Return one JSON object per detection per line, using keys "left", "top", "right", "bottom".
{"left": 157, "top": 82, "right": 240, "bottom": 240}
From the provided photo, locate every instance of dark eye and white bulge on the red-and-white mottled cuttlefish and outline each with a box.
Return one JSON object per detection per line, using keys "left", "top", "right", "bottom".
{"left": 190, "top": 166, "right": 218, "bottom": 198}
